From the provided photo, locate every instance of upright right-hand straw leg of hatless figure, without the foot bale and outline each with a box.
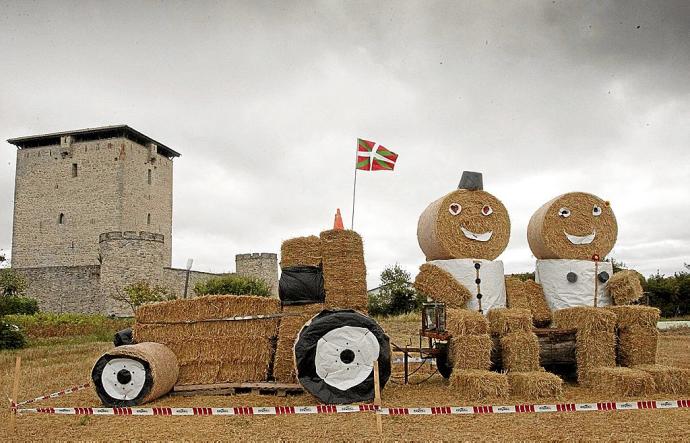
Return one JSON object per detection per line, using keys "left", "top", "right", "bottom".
{"left": 606, "top": 306, "right": 660, "bottom": 367}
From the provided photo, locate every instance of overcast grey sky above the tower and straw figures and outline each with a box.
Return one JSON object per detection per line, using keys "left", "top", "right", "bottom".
{"left": 0, "top": 1, "right": 690, "bottom": 286}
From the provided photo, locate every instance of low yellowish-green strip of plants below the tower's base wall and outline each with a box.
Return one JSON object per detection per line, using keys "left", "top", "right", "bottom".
{"left": 5, "top": 312, "right": 134, "bottom": 341}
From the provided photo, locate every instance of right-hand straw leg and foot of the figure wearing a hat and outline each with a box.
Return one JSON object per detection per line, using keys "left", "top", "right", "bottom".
{"left": 489, "top": 308, "right": 563, "bottom": 399}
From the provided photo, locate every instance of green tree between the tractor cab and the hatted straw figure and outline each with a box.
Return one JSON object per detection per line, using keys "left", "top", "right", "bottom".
{"left": 369, "top": 263, "right": 422, "bottom": 315}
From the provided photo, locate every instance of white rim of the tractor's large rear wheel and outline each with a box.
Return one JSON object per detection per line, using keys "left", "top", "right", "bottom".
{"left": 314, "top": 326, "right": 380, "bottom": 391}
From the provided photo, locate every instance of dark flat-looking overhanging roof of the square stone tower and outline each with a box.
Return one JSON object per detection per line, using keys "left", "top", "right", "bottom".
{"left": 7, "top": 125, "right": 180, "bottom": 158}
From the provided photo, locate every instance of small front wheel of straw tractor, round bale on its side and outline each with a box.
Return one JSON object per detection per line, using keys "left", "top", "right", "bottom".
{"left": 91, "top": 342, "right": 179, "bottom": 407}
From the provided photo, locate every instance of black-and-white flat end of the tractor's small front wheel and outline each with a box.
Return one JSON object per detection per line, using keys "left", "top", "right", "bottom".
{"left": 91, "top": 354, "right": 153, "bottom": 407}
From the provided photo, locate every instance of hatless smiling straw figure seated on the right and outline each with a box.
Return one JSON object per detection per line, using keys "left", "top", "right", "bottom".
{"left": 527, "top": 192, "right": 690, "bottom": 395}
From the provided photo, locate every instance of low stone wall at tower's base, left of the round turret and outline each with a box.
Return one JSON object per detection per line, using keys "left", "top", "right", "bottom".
{"left": 17, "top": 265, "right": 105, "bottom": 314}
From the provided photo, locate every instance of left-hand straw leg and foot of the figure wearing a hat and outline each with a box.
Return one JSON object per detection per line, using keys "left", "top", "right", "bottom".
{"left": 446, "top": 308, "right": 509, "bottom": 400}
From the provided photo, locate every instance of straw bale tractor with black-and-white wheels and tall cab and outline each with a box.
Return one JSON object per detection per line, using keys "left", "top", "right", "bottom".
{"left": 92, "top": 229, "right": 391, "bottom": 406}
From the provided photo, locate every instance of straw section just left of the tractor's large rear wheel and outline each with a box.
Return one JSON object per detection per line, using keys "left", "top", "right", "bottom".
{"left": 273, "top": 303, "right": 324, "bottom": 383}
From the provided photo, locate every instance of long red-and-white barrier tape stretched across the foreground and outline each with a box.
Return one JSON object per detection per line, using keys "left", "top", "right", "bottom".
{"left": 17, "top": 400, "right": 690, "bottom": 416}
